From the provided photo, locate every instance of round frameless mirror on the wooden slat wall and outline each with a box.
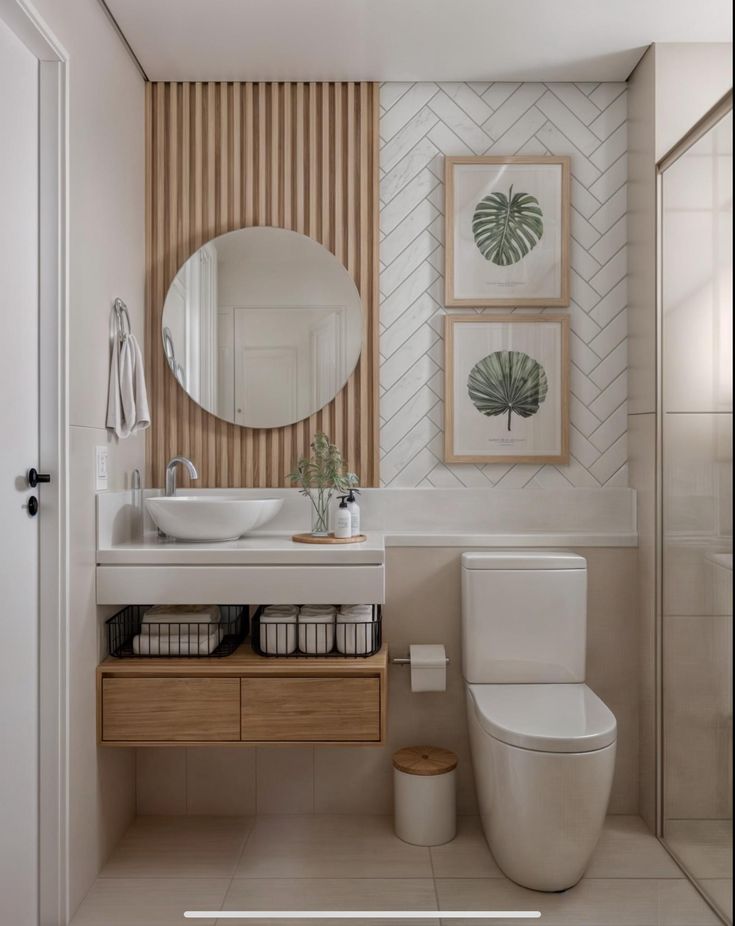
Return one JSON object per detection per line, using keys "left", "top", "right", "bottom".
{"left": 161, "top": 227, "right": 363, "bottom": 428}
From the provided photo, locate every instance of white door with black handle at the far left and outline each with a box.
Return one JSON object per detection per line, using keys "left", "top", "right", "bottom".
{"left": 0, "top": 20, "right": 42, "bottom": 926}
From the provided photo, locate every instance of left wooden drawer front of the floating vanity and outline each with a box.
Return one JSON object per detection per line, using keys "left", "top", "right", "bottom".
{"left": 101, "top": 678, "right": 240, "bottom": 743}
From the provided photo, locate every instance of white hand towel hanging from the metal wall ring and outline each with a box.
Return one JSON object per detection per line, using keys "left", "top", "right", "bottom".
{"left": 107, "top": 333, "right": 151, "bottom": 438}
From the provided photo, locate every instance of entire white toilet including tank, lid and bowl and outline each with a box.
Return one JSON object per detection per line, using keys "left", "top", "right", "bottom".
{"left": 462, "top": 551, "right": 616, "bottom": 891}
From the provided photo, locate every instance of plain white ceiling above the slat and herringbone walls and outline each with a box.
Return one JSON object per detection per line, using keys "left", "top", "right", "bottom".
{"left": 107, "top": 0, "right": 732, "bottom": 81}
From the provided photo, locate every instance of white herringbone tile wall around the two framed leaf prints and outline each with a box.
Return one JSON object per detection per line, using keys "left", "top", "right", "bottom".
{"left": 380, "top": 83, "right": 627, "bottom": 487}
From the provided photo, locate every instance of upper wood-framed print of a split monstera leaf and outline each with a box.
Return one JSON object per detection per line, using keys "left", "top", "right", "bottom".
{"left": 444, "top": 156, "right": 570, "bottom": 306}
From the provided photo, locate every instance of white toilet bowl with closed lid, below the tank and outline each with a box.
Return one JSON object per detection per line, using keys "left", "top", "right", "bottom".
{"left": 467, "top": 685, "right": 616, "bottom": 891}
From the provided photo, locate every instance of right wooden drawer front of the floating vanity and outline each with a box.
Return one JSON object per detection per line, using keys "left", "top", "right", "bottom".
{"left": 241, "top": 678, "right": 380, "bottom": 743}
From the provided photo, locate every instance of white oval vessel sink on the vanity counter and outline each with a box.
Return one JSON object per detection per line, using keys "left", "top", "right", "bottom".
{"left": 146, "top": 495, "right": 283, "bottom": 543}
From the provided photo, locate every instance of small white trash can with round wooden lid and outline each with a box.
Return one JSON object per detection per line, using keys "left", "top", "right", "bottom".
{"left": 393, "top": 746, "right": 457, "bottom": 846}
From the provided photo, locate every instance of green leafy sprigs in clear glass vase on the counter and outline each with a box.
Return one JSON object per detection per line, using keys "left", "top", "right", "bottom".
{"left": 287, "top": 431, "right": 359, "bottom": 537}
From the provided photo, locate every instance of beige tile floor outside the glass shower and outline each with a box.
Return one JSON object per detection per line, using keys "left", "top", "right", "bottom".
{"left": 72, "top": 815, "right": 719, "bottom": 926}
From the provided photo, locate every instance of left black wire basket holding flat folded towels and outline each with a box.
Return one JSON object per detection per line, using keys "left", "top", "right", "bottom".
{"left": 106, "top": 604, "right": 248, "bottom": 659}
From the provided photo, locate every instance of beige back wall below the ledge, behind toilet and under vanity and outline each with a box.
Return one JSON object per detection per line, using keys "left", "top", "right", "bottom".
{"left": 137, "top": 547, "right": 638, "bottom": 814}
